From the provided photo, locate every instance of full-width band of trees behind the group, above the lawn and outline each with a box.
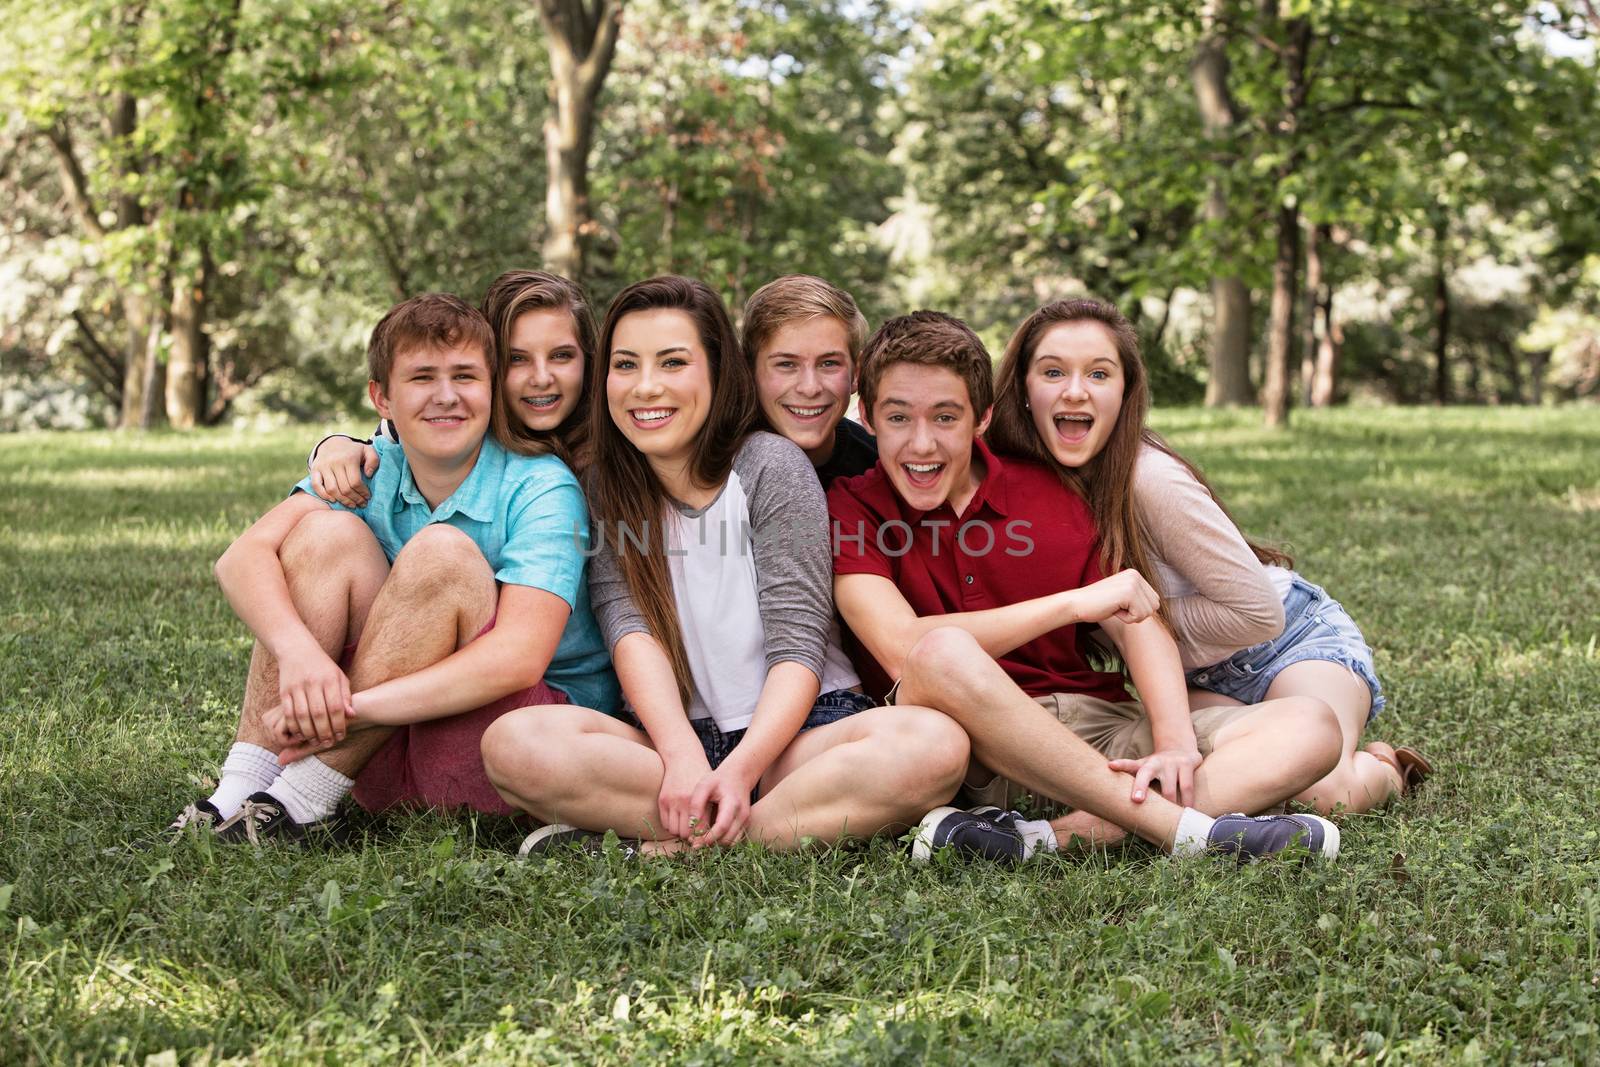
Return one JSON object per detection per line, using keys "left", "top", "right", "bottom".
{"left": 0, "top": 0, "right": 1600, "bottom": 429}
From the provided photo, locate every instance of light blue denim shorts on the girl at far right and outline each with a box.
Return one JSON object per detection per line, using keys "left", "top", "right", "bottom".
{"left": 1187, "top": 574, "right": 1386, "bottom": 721}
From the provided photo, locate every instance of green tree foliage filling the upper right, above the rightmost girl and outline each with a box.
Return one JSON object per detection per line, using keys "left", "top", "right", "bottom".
{"left": 901, "top": 0, "right": 1600, "bottom": 421}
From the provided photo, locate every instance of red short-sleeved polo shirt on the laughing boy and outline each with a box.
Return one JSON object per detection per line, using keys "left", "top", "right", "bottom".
{"left": 827, "top": 438, "right": 1128, "bottom": 701}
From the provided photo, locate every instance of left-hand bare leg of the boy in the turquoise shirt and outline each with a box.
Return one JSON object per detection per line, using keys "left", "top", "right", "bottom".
{"left": 235, "top": 510, "right": 389, "bottom": 752}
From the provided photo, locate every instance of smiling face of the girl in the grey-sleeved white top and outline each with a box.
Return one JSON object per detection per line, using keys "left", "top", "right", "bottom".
{"left": 605, "top": 307, "right": 712, "bottom": 472}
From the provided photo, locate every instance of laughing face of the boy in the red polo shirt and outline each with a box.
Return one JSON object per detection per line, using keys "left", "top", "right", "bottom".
{"left": 870, "top": 363, "right": 989, "bottom": 514}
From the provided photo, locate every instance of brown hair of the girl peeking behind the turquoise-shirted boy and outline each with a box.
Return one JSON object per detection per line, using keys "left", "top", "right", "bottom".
{"left": 482, "top": 270, "right": 598, "bottom": 469}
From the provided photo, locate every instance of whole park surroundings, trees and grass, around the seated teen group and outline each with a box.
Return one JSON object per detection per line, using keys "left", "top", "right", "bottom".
{"left": 0, "top": 0, "right": 1600, "bottom": 1064}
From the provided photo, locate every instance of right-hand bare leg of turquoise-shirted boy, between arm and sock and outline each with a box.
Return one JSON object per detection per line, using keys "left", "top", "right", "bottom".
{"left": 315, "top": 525, "right": 498, "bottom": 777}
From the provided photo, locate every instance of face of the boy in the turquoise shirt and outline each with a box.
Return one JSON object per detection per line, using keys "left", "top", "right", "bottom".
{"left": 368, "top": 342, "right": 494, "bottom": 464}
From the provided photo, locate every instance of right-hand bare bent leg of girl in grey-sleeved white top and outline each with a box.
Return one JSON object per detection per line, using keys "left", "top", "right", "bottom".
{"left": 746, "top": 705, "right": 968, "bottom": 849}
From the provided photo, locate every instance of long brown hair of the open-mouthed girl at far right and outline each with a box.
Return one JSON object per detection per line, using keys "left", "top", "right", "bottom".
{"left": 986, "top": 299, "right": 1294, "bottom": 601}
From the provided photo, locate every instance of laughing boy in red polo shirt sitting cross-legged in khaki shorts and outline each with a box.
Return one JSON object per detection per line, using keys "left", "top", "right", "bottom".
{"left": 827, "top": 312, "right": 1339, "bottom": 862}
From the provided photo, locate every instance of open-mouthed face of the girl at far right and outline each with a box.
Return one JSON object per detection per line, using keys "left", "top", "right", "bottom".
{"left": 1024, "top": 320, "right": 1126, "bottom": 467}
